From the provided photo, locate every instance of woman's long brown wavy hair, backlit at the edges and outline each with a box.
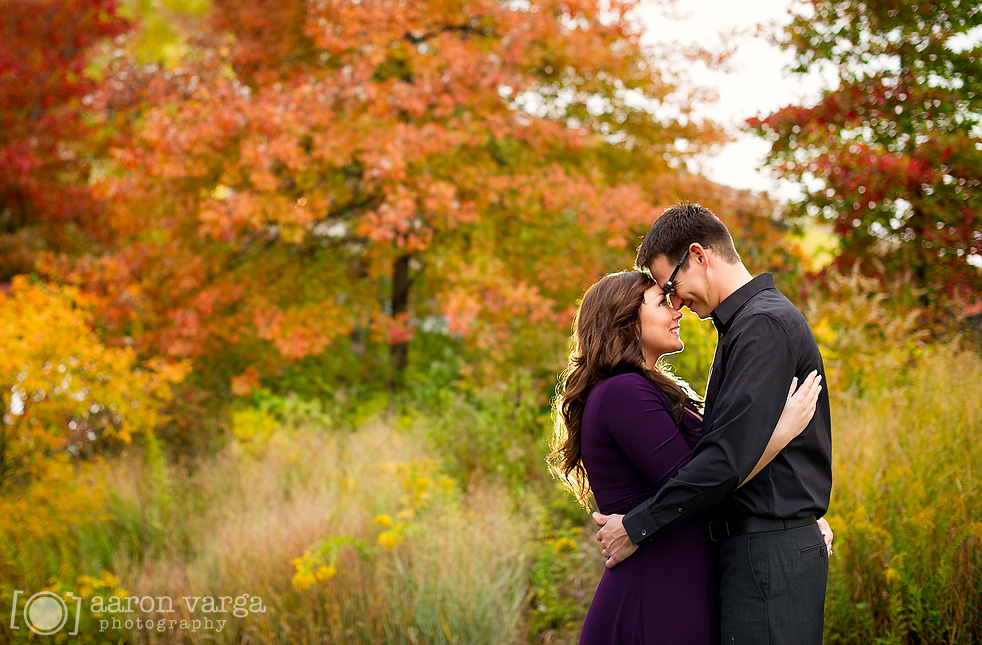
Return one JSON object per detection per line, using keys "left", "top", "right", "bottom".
{"left": 548, "top": 271, "right": 701, "bottom": 508}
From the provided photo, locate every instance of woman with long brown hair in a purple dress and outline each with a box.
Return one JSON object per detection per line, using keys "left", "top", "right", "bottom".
{"left": 550, "top": 272, "right": 821, "bottom": 644}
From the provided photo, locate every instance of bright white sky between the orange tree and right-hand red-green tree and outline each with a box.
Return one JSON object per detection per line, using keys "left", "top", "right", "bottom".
{"left": 639, "top": 0, "right": 828, "bottom": 198}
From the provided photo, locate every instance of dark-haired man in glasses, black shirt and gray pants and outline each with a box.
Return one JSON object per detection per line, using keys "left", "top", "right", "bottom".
{"left": 594, "top": 203, "right": 832, "bottom": 645}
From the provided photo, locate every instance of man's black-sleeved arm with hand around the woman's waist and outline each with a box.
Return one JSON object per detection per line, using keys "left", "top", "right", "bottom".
{"left": 595, "top": 315, "right": 795, "bottom": 567}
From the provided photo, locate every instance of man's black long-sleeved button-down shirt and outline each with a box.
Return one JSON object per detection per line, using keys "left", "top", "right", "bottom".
{"left": 624, "top": 273, "right": 832, "bottom": 544}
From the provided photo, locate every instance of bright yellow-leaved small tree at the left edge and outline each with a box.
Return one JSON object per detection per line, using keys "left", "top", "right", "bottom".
{"left": 0, "top": 276, "right": 186, "bottom": 495}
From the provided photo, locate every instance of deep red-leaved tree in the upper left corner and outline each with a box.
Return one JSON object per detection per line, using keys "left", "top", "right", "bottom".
{"left": 0, "top": 0, "right": 130, "bottom": 281}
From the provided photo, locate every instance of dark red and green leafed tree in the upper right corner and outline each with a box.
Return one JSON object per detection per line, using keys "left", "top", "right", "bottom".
{"left": 751, "top": 0, "right": 982, "bottom": 302}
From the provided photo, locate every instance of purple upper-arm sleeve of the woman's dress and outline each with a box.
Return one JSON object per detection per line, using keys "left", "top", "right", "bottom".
{"left": 598, "top": 374, "right": 691, "bottom": 486}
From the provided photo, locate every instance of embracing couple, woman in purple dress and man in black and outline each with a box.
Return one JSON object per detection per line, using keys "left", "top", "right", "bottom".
{"left": 552, "top": 203, "right": 832, "bottom": 645}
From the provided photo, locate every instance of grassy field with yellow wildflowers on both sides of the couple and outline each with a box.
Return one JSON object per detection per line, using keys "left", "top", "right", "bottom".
{"left": 0, "top": 340, "right": 982, "bottom": 644}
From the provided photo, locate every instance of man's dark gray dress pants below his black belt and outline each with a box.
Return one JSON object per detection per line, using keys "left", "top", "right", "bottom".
{"left": 717, "top": 524, "right": 829, "bottom": 645}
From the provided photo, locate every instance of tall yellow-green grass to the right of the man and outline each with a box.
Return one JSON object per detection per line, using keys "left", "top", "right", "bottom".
{"left": 826, "top": 346, "right": 982, "bottom": 643}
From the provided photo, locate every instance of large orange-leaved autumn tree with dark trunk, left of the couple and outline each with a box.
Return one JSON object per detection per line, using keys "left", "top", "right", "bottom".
{"left": 49, "top": 0, "right": 732, "bottom": 402}
